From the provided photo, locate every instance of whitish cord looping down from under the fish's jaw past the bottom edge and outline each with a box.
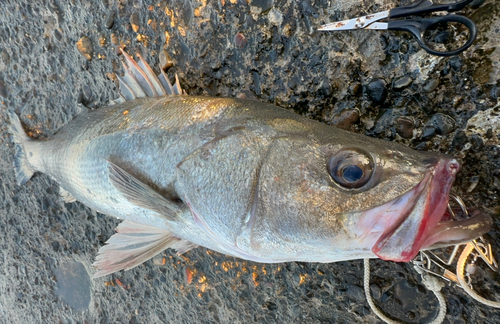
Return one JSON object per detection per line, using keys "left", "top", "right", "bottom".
{"left": 364, "top": 259, "right": 446, "bottom": 324}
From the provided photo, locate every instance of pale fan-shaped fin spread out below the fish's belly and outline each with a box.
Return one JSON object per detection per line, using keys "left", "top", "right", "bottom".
{"left": 93, "top": 221, "right": 197, "bottom": 278}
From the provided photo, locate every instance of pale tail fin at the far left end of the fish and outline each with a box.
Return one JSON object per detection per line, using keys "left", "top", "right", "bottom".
{"left": 9, "top": 112, "right": 35, "bottom": 185}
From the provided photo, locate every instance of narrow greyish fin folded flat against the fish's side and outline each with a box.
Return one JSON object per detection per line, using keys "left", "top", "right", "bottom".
{"left": 108, "top": 161, "right": 183, "bottom": 221}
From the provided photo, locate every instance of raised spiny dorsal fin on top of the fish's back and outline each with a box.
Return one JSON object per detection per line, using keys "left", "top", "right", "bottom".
{"left": 110, "top": 49, "right": 186, "bottom": 104}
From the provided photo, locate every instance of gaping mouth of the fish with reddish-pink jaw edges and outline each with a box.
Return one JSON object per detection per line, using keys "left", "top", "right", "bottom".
{"left": 363, "top": 157, "right": 492, "bottom": 262}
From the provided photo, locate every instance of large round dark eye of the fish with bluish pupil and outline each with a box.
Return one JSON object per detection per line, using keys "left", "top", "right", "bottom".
{"left": 327, "top": 149, "right": 373, "bottom": 189}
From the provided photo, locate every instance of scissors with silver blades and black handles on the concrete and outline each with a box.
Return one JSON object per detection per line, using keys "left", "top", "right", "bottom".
{"left": 318, "top": 0, "right": 477, "bottom": 56}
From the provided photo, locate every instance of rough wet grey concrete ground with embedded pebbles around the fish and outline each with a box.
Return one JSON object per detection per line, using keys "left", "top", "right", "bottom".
{"left": 0, "top": 0, "right": 500, "bottom": 323}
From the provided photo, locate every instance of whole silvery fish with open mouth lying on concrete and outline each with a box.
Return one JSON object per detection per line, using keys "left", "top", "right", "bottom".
{"left": 9, "top": 51, "right": 492, "bottom": 278}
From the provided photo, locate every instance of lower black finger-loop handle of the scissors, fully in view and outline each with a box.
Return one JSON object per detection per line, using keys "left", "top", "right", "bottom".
{"left": 387, "top": 15, "right": 477, "bottom": 56}
